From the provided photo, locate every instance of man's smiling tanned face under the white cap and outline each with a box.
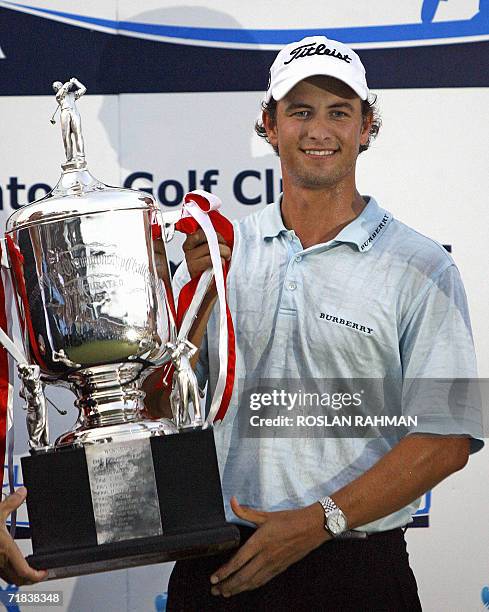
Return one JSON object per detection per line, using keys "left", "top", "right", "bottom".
{"left": 263, "top": 76, "right": 372, "bottom": 189}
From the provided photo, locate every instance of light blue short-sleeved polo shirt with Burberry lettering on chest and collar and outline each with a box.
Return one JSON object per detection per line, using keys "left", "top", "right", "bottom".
{"left": 174, "top": 198, "right": 483, "bottom": 532}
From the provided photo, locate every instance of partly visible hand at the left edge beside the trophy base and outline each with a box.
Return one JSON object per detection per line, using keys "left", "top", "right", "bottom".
{"left": 0, "top": 487, "right": 47, "bottom": 586}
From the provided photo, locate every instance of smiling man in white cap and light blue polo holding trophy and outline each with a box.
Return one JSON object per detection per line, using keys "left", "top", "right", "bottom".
{"left": 162, "top": 36, "right": 482, "bottom": 612}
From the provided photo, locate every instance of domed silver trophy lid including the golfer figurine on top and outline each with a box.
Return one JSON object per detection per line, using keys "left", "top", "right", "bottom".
{"left": 6, "top": 78, "right": 158, "bottom": 233}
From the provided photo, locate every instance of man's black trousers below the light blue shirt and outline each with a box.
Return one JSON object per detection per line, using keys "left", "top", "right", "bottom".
{"left": 166, "top": 527, "right": 421, "bottom": 612}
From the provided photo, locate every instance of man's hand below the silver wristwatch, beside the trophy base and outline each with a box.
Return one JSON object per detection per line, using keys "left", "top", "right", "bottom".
{"left": 211, "top": 497, "right": 331, "bottom": 597}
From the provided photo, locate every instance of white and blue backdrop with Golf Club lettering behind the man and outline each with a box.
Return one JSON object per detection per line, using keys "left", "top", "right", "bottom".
{"left": 0, "top": 0, "right": 489, "bottom": 612}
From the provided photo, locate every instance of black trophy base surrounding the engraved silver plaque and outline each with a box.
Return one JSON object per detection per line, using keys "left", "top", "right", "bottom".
{"left": 21, "top": 429, "right": 239, "bottom": 579}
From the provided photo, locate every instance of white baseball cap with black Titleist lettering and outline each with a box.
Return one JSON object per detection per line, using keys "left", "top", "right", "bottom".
{"left": 265, "top": 36, "right": 369, "bottom": 102}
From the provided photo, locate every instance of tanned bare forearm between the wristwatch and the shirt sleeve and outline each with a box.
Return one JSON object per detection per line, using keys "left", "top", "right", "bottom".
{"left": 331, "top": 435, "right": 470, "bottom": 529}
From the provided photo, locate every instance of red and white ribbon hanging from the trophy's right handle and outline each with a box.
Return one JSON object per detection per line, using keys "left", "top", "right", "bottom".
{"left": 176, "top": 190, "right": 236, "bottom": 426}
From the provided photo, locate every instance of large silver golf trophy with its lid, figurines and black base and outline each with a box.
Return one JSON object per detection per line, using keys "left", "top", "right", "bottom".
{"left": 4, "top": 78, "right": 237, "bottom": 577}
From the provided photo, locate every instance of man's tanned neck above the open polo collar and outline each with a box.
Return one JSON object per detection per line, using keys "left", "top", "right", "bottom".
{"left": 282, "top": 181, "right": 365, "bottom": 249}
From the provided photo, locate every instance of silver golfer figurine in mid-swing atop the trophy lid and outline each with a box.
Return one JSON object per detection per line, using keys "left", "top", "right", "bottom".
{"left": 51, "top": 77, "right": 87, "bottom": 171}
